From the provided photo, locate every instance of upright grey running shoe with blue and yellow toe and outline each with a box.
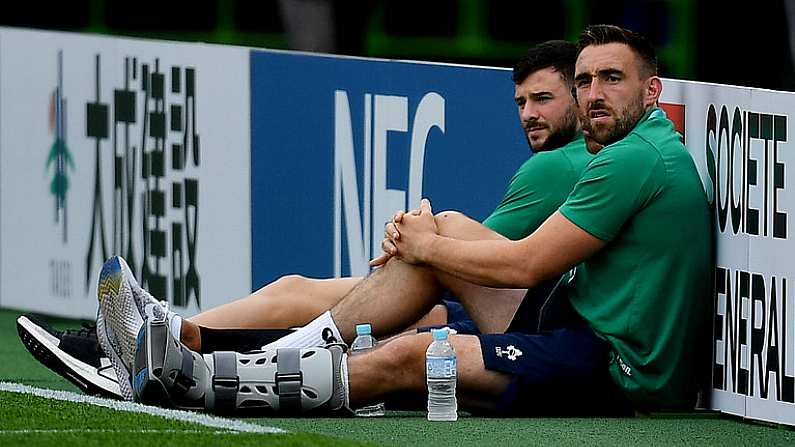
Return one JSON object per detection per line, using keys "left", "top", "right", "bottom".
{"left": 97, "top": 256, "right": 181, "bottom": 400}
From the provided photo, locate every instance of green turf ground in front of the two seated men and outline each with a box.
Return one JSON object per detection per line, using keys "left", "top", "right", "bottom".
{"left": 0, "top": 310, "right": 795, "bottom": 447}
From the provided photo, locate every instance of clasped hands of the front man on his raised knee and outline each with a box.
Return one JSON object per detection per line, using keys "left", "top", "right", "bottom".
{"left": 370, "top": 199, "right": 438, "bottom": 267}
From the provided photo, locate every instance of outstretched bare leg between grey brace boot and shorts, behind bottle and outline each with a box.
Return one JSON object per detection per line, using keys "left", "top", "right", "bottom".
{"left": 348, "top": 333, "right": 510, "bottom": 408}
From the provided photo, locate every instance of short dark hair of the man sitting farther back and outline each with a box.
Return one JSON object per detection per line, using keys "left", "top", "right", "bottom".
{"left": 512, "top": 40, "right": 577, "bottom": 85}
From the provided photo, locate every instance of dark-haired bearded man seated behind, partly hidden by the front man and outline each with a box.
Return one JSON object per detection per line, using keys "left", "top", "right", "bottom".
{"left": 18, "top": 41, "right": 591, "bottom": 406}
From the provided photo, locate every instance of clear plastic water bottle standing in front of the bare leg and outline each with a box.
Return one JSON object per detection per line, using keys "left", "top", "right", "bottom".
{"left": 425, "top": 328, "right": 458, "bottom": 421}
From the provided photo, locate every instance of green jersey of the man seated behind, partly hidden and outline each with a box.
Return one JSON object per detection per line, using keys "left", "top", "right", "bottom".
{"left": 483, "top": 134, "right": 593, "bottom": 240}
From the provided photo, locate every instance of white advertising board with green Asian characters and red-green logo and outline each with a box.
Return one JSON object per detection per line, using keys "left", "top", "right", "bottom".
{"left": 0, "top": 29, "right": 251, "bottom": 318}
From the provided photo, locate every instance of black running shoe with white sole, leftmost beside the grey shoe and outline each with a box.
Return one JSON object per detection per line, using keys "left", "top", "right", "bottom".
{"left": 17, "top": 315, "right": 124, "bottom": 399}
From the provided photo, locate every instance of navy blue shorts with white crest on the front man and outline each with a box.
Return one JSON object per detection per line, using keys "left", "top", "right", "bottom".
{"left": 430, "top": 281, "right": 634, "bottom": 416}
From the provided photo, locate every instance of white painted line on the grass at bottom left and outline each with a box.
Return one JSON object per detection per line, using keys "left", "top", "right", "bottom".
{"left": 0, "top": 382, "right": 287, "bottom": 433}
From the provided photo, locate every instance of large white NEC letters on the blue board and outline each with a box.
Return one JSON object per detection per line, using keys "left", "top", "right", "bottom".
{"left": 334, "top": 90, "right": 445, "bottom": 277}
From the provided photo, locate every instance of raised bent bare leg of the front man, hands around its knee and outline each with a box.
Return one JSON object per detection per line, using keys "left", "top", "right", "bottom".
{"left": 331, "top": 211, "right": 526, "bottom": 342}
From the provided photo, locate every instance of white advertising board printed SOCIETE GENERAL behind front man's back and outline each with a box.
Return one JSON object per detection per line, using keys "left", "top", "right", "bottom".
{"left": 662, "top": 80, "right": 795, "bottom": 425}
